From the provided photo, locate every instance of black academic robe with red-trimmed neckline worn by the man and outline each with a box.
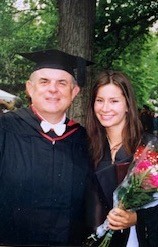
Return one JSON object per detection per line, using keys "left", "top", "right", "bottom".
{"left": 0, "top": 109, "right": 90, "bottom": 246}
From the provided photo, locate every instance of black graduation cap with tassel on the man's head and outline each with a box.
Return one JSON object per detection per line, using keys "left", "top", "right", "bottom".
{"left": 19, "top": 50, "right": 93, "bottom": 87}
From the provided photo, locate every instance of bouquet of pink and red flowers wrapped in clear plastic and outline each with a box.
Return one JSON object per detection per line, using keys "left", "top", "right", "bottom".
{"left": 83, "top": 138, "right": 158, "bottom": 247}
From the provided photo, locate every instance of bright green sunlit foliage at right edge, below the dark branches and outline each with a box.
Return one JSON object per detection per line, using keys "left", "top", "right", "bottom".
{"left": 112, "top": 34, "right": 158, "bottom": 109}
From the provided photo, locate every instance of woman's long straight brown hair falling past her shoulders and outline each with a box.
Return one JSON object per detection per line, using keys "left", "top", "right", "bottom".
{"left": 86, "top": 70, "right": 141, "bottom": 166}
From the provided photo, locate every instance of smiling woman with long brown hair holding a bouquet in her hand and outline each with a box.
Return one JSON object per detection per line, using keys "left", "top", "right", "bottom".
{"left": 87, "top": 70, "right": 158, "bottom": 247}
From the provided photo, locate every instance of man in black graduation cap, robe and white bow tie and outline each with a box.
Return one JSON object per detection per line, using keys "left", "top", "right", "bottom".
{"left": 0, "top": 50, "right": 91, "bottom": 246}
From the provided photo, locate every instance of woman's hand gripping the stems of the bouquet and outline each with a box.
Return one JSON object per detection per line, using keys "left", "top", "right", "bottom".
{"left": 107, "top": 208, "right": 137, "bottom": 230}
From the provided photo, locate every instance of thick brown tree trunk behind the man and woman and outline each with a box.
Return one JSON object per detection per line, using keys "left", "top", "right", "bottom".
{"left": 57, "top": 0, "right": 96, "bottom": 125}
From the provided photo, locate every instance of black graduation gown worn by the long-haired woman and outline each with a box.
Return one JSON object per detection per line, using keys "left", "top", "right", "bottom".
{"left": 96, "top": 134, "right": 158, "bottom": 247}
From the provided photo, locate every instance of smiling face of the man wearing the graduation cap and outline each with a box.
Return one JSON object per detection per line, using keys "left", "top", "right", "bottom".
{"left": 26, "top": 68, "right": 80, "bottom": 118}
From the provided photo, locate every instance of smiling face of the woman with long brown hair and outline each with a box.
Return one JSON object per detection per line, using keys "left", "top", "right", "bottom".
{"left": 94, "top": 84, "right": 128, "bottom": 130}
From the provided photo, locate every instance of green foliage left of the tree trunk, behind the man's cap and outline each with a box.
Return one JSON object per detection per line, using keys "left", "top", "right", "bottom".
{"left": 0, "top": 0, "right": 58, "bottom": 91}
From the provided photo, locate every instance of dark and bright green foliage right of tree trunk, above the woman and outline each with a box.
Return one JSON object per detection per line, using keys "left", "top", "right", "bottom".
{"left": 95, "top": 0, "right": 158, "bottom": 108}
